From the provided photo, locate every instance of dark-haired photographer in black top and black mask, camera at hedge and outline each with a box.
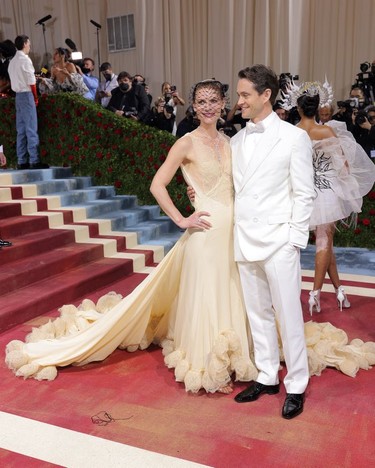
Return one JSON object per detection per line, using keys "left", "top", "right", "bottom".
{"left": 107, "top": 71, "right": 151, "bottom": 123}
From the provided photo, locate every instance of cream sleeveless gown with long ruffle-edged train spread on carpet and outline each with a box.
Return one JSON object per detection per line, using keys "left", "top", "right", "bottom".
{"left": 6, "top": 131, "right": 375, "bottom": 392}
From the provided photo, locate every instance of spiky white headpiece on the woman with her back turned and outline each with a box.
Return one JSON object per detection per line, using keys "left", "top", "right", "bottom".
{"left": 281, "top": 77, "right": 333, "bottom": 110}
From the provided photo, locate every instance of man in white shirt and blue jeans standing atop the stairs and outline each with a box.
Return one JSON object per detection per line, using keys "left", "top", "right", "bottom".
{"left": 8, "top": 35, "right": 49, "bottom": 169}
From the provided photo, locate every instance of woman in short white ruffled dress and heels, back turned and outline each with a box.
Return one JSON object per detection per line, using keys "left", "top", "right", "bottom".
{"left": 297, "top": 89, "right": 375, "bottom": 314}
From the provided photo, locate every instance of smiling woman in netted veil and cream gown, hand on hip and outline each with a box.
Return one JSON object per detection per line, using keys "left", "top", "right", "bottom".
{"left": 6, "top": 80, "right": 257, "bottom": 393}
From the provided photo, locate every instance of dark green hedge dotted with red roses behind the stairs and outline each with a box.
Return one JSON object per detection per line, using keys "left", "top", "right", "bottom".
{"left": 0, "top": 93, "right": 375, "bottom": 249}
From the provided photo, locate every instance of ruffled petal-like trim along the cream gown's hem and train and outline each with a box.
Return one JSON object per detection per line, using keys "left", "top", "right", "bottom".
{"left": 5, "top": 293, "right": 375, "bottom": 393}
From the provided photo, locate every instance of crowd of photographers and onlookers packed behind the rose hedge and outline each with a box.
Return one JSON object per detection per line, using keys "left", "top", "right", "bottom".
{"left": 0, "top": 35, "right": 375, "bottom": 155}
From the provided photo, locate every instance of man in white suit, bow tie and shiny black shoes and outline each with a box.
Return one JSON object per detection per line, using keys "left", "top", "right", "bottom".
{"left": 231, "top": 65, "right": 315, "bottom": 419}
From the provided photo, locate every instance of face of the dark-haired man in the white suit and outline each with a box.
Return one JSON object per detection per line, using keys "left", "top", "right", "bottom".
{"left": 237, "top": 78, "right": 271, "bottom": 123}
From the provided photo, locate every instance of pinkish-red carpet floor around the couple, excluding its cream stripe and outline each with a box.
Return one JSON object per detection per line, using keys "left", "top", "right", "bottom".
{"left": 0, "top": 275, "right": 375, "bottom": 468}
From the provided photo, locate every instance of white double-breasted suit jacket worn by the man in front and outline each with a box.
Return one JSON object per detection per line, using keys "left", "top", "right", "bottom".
{"left": 231, "top": 113, "right": 315, "bottom": 262}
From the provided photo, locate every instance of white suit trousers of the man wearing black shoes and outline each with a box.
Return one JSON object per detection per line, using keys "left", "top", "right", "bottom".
{"left": 238, "top": 244, "right": 309, "bottom": 393}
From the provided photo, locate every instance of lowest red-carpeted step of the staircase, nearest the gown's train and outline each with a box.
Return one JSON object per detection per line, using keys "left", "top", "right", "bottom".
{"left": 0, "top": 258, "right": 137, "bottom": 332}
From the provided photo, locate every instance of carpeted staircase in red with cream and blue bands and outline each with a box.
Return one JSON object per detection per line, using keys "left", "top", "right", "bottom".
{"left": 0, "top": 168, "right": 181, "bottom": 332}
